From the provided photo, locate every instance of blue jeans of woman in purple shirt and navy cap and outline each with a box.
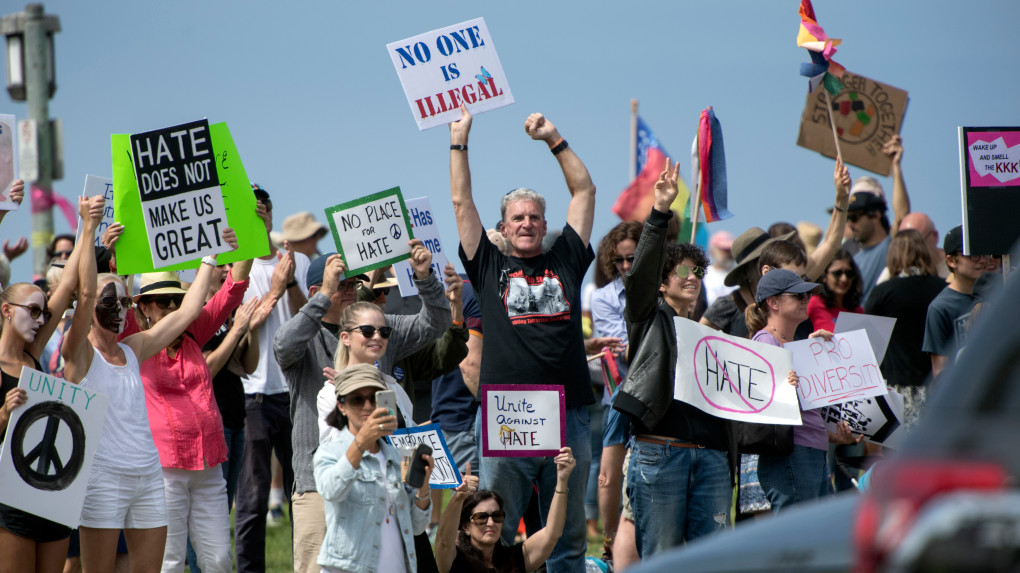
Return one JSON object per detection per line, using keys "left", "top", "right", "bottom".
{"left": 758, "top": 445, "right": 831, "bottom": 512}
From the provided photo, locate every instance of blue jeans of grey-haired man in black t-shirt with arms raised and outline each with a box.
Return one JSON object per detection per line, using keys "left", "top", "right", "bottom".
{"left": 475, "top": 406, "right": 592, "bottom": 573}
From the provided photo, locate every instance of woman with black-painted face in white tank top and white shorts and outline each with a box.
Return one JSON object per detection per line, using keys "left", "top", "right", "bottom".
{"left": 61, "top": 197, "right": 239, "bottom": 572}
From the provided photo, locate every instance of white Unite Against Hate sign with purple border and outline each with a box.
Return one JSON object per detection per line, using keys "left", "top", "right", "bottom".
{"left": 481, "top": 384, "right": 567, "bottom": 458}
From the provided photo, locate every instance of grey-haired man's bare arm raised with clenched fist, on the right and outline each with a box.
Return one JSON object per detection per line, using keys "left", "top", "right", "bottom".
{"left": 524, "top": 113, "right": 595, "bottom": 246}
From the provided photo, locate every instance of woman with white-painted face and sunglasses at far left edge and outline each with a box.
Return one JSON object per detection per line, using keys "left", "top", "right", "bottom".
{"left": 0, "top": 190, "right": 102, "bottom": 572}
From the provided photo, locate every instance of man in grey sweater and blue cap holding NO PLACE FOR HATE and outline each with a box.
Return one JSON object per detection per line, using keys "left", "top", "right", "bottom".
{"left": 272, "top": 240, "right": 452, "bottom": 573}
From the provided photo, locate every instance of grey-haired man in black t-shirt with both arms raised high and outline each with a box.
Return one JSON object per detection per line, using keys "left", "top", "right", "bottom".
{"left": 450, "top": 106, "right": 595, "bottom": 573}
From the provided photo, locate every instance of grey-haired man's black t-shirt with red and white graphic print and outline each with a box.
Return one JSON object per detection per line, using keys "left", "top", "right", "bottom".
{"left": 459, "top": 225, "right": 595, "bottom": 408}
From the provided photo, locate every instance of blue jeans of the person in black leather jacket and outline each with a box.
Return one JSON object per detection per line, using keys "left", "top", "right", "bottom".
{"left": 627, "top": 439, "right": 733, "bottom": 559}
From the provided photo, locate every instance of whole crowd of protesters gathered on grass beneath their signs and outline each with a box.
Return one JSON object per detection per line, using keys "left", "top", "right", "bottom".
{"left": 0, "top": 102, "right": 1002, "bottom": 573}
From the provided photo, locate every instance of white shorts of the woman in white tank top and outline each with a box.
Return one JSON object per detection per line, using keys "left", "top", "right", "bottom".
{"left": 82, "top": 468, "right": 166, "bottom": 529}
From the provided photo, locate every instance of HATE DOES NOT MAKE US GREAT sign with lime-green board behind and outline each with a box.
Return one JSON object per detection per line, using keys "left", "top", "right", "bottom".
{"left": 110, "top": 119, "right": 269, "bottom": 274}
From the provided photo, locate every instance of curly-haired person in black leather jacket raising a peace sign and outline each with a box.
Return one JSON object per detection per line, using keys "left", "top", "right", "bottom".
{"left": 613, "top": 159, "right": 732, "bottom": 559}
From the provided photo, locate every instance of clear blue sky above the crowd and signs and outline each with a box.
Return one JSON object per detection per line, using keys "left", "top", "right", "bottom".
{"left": 0, "top": 0, "right": 1020, "bottom": 279}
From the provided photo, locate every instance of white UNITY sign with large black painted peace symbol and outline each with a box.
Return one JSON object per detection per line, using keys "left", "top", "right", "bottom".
{"left": 0, "top": 368, "right": 109, "bottom": 528}
